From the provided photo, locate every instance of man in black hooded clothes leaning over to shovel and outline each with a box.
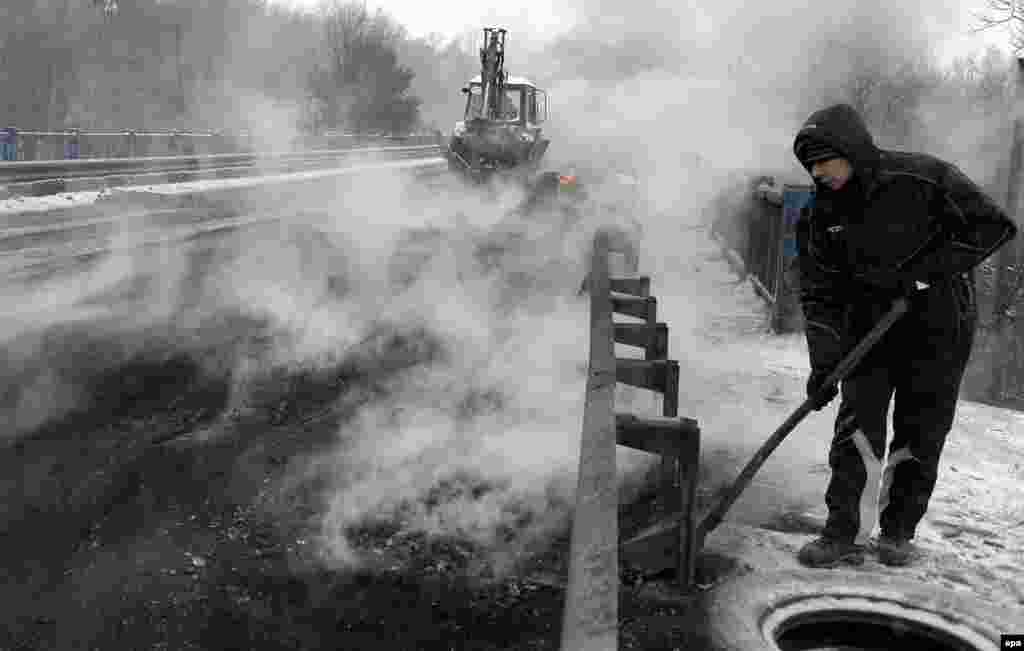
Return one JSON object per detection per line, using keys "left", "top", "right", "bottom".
{"left": 794, "top": 104, "right": 1017, "bottom": 567}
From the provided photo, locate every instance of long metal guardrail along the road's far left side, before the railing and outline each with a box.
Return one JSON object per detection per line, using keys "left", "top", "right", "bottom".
{"left": 0, "top": 144, "right": 440, "bottom": 196}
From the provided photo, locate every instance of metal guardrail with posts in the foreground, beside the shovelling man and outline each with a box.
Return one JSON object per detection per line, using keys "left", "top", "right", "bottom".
{"left": 561, "top": 230, "right": 700, "bottom": 651}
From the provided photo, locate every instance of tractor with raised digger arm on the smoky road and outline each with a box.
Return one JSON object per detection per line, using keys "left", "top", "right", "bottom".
{"left": 445, "top": 28, "right": 558, "bottom": 184}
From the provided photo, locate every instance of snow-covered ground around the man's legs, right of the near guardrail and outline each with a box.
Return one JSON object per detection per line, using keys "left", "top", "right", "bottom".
{"left": 655, "top": 225, "right": 1024, "bottom": 607}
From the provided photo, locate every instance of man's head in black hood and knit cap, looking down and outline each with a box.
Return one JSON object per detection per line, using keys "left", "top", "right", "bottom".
{"left": 793, "top": 104, "right": 881, "bottom": 188}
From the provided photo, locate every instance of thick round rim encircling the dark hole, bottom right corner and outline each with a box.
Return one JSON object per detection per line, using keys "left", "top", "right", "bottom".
{"left": 702, "top": 569, "right": 1024, "bottom": 651}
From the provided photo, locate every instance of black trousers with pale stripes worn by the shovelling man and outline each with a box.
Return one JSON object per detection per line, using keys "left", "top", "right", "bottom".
{"left": 823, "top": 275, "right": 977, "bottom": 544}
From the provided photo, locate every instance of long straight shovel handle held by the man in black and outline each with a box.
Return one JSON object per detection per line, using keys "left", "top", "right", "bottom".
{"left": 695, "top": 298, "right": 909, "bottom": 549}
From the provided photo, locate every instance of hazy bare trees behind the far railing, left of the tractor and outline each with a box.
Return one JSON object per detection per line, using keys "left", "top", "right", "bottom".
{"left": 0, "top": 0, "right": 475, "bottom": 132}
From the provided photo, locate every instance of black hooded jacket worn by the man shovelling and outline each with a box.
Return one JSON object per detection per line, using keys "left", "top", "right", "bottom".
{"left": 794, "top": 104, "right": 1017, "bottom": 372}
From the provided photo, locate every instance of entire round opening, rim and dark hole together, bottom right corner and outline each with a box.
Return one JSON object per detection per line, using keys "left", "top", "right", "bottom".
{"left": 702, "top": 570, "right": 1024, "bottom": 651}
